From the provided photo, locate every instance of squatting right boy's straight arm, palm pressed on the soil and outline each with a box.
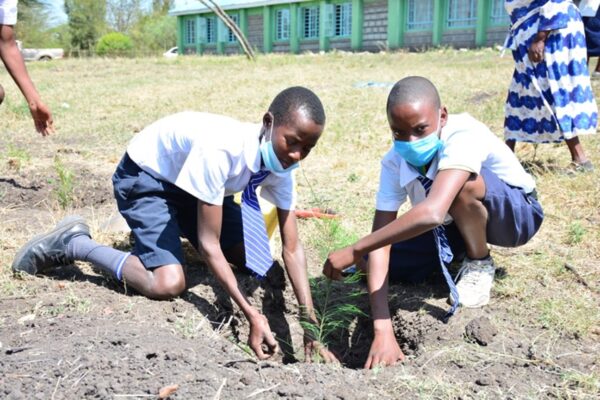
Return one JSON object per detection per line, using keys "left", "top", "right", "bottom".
{"left": 364, "top": 210, "right": 404, "bottom": 369}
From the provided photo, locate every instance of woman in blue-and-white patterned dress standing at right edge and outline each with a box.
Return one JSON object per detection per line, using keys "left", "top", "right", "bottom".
{"left": 504, "top": 0, "right": 598, "bottom": 171}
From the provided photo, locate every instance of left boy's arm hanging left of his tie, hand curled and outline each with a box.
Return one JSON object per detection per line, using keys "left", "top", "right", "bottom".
{"left": 198, "top": 200, "right": 277, "bottom": 360}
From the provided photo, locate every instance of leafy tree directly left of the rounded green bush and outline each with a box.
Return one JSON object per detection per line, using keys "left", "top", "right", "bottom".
{"left": 65, "top": 0, "right": 106, "bottom": 50}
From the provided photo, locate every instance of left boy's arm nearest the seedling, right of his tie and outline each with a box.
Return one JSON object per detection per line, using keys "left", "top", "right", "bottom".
{"left": 277, "top": 208, "right": 338, "bottom": 362}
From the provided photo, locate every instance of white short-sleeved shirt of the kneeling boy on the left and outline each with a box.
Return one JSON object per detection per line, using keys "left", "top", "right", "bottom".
{"left": 127, "top": 111, "right": 295, "bottom": 210}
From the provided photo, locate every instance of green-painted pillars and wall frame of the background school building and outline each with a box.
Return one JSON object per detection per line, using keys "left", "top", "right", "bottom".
{"left": 177, "top": 0, "right": 508, "bottom": 54}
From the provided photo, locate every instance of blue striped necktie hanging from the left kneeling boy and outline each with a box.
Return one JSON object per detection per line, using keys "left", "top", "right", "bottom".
{"left": 242, "top": 170, "right": 273, "bottom": 277}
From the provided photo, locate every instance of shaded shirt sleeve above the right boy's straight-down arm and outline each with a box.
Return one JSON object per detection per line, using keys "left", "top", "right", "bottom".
{"left": 375, "top": 153, "right": 407, "bottom": 211}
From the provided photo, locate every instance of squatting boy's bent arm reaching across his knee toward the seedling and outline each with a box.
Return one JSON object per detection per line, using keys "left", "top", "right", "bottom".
{"left": 323, "top": 169, "right": 471, "bottom": 279}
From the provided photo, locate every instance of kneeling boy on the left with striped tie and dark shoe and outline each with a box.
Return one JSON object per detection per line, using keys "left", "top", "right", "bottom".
{"left": 13, "top": 87, "right": 335, "bottom": 361}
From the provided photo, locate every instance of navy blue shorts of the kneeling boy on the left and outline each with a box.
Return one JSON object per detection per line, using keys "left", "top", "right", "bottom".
{"left": 112, "top": 153, "right": 244, "bottom": 269}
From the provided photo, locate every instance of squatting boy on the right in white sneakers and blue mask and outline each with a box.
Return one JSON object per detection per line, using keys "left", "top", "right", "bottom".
{"left": 323, "top": 77, "right": 543, "bottom": 368}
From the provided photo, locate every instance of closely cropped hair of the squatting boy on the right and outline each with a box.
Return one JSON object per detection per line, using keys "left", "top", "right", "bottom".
{"left": 387, "top": 76, "right": 442, "bottom": 114}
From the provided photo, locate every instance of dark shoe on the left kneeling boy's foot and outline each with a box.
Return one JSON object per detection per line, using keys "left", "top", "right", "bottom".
{"left": 12, "top": 215, "right": 91, "bottom": 275}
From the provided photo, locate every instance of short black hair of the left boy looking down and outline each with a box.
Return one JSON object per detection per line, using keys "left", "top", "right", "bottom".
{"left": 269, "top": 86, "right": 325, "bottom": 126}
